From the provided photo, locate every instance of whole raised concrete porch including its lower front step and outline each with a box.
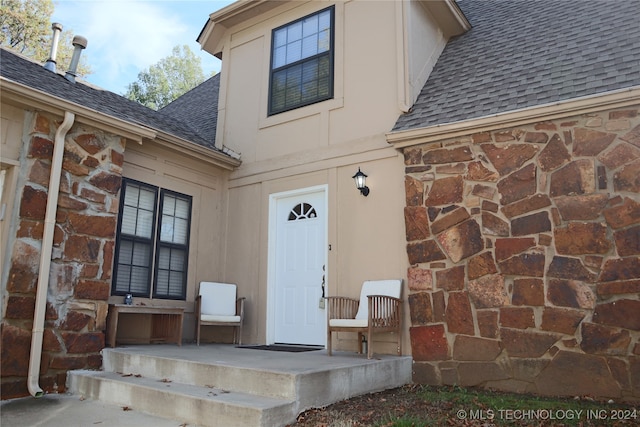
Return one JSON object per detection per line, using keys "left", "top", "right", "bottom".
{"left": 67, "top": 344, "right": 412, "bottom": 427}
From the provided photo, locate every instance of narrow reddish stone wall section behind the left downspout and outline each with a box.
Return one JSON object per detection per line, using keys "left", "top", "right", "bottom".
{"left": 1, "top": 113, "right": 124, "bottom": 399}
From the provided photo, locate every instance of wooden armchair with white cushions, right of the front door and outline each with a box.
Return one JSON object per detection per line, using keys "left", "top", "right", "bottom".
{"left": 327, "top": 279, "right": 402, "bottom": 359}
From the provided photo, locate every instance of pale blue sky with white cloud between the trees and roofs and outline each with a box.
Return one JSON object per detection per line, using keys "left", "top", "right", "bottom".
{"left": 51, "top": 0, "right": 233, "bottom": 94}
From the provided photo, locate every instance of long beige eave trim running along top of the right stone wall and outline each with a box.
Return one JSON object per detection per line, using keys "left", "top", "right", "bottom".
{"left": 386, "top": 86, "right": 640, "bottom": 149}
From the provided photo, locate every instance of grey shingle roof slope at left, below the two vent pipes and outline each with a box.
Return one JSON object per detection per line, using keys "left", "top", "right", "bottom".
{"left": 0, "top": 48, "right": 220, "bottom": 151}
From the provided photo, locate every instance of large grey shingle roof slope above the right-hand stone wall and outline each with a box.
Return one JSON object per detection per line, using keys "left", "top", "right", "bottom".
{"left": 393, "top": 0, "right": 640, "bottom": 131}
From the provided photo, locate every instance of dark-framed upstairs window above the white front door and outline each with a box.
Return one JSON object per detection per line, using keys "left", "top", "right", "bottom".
{"left": 269, "top": 7, "right": 334, "bottom": 115}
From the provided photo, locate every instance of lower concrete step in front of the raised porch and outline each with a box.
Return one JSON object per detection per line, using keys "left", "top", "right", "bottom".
{"left": 67, "top": 370, "right": 296, "bottom": 427}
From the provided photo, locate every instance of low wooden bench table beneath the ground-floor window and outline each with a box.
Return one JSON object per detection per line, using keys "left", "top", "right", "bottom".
{"left": 107, "top": 304, "right": 184, "bottom": 348}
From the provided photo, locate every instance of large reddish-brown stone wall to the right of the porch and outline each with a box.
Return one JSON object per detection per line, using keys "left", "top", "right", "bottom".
{"left": 404, "top": 106, "right": 640, "bottom": 400}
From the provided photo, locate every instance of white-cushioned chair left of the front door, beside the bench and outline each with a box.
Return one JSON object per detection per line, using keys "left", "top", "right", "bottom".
{"left": 195, "top": 282, "right": 245, "bottom": 345}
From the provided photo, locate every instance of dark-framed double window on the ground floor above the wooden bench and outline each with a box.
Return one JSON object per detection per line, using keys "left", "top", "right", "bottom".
{"left": 111, "top": 178, "right": 191, "bottom": 300}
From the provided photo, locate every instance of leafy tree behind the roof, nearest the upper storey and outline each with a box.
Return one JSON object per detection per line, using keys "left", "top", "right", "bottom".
{"left": 124, "top": 45, "right": 205, "bottom": 110}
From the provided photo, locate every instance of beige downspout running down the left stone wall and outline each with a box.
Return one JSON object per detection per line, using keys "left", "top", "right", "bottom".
{"left": 27, "top": 111, "right": 76, "bottom": 397}
